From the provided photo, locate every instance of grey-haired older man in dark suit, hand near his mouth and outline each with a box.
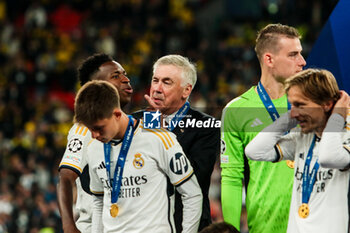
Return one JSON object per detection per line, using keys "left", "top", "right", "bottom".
{"left": 134, "top": 55, "right": 220, "bottom": 232}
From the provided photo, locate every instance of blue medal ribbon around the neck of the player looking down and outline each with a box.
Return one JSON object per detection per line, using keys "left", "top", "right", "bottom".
{"left": 103, "top": 116, "right": 135, "bottom": 203}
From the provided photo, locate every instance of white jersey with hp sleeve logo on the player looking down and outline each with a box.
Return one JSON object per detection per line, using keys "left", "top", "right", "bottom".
{"left": 88, "top": 122, "right": 193, "bottom": 233}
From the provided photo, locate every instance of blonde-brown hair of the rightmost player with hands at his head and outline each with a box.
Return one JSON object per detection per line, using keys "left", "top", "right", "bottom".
{"left": 284, "top": 69, "right": 340, "bottom": 104}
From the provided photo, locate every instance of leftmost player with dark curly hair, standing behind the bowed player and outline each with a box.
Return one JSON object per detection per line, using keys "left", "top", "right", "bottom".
{"left": 57, "top": 54, "right": 133, "bottom": 233}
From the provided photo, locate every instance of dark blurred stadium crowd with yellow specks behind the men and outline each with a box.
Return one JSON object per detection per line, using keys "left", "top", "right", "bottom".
{"left": 0, "top": 0, "right": 338, "bottom": 233}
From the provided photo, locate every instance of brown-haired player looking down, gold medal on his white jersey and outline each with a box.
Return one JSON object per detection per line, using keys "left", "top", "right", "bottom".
{"left": 74, "top": 80, "right": 202, "bottom": 233}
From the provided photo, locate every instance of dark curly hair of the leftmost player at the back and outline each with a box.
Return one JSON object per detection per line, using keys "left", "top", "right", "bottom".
{"left": 78, "top": 53, "right": 113, "bottom": 86}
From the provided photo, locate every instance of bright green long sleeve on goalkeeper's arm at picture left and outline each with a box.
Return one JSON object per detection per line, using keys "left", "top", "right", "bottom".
{"left": 220, "top": 104, "right": 244, "bottom": 229}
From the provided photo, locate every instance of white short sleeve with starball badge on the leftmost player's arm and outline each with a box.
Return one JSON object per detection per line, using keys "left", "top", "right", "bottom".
{"left": 59, "top": 124, "right": 92, "bottom": 176}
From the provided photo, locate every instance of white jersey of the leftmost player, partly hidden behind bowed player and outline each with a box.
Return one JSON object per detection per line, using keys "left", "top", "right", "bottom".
{"left": 59, "top": 124, "right": 92, "bottom": 232}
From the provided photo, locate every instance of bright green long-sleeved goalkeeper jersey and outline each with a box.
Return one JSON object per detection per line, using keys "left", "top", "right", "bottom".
{"left": 221, "top": 87, "right": 293, "bottom": 233}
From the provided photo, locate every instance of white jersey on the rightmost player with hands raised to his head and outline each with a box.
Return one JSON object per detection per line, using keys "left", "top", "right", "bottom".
{"left": 279, "top": 123, "right": 350, "bottom": 233}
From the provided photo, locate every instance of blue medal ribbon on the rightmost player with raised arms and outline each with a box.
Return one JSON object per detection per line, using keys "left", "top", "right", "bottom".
{"left": 302, "top": 135, "right": 320, "bottom": 204}
